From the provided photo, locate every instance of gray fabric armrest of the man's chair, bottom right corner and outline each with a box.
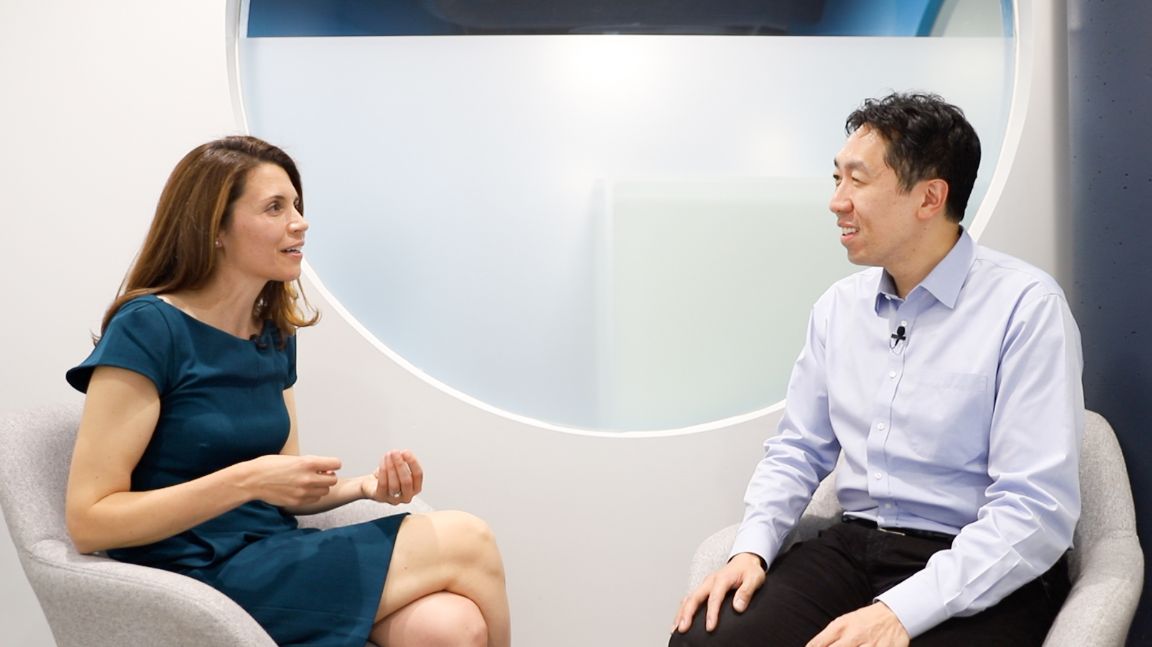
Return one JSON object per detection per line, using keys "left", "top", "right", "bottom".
{"left": 1044, "top": 534, "right": 1144, "bottom": 647}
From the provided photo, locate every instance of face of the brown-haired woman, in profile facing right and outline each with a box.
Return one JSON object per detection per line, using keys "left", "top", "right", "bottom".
{"left": 218, "top": 163, "right": 308, "bottom": 286}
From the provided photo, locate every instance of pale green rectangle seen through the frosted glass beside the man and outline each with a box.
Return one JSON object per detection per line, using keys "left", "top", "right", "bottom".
{"left": 599, "top": 177, "right": 852, "bottom": 428}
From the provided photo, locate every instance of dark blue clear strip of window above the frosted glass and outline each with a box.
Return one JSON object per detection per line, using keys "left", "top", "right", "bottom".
{"left": 247, "top": 0, "right": 940, "bottom": 38}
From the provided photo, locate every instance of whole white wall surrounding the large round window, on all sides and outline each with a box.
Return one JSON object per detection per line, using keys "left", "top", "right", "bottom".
{"left": 0, "top": 0, "right": 1067, "bottom": 647}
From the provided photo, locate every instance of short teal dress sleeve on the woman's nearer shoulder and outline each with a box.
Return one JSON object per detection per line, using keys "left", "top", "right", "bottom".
{"left": 65, "top": 302, "right": 172, "bottom": 394}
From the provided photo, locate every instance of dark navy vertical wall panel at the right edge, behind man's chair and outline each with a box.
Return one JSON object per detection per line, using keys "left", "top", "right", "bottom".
{"left": 1068, "top": 0, "right": 1152, "bottom": 645}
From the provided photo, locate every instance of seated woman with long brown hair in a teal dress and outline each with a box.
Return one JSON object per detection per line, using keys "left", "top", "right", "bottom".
{"left": 67, "top": 137, "right": 510, "bottom": 647}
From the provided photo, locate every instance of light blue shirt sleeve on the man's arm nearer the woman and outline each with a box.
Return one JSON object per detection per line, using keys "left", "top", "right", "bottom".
{"left": 732, "top": 294, "right": 840, "bottom": 564}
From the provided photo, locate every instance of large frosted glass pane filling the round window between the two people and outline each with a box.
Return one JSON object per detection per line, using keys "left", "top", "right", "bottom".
{"left": 241, "top": 36, "right": 1011, "bottom": 429}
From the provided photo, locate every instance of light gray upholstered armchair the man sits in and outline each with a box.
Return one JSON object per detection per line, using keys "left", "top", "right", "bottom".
{"left": 689, "top": 411, "right": 1144, "bottom": 647}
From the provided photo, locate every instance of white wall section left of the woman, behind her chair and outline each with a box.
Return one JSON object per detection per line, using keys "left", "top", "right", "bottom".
{"left": 0, "top": 0, "right": 234, "bottom": 646}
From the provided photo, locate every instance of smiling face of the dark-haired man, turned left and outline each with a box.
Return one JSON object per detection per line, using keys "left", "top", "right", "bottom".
{"left": 828, "top": 125, "right": 924, "bottom": 271}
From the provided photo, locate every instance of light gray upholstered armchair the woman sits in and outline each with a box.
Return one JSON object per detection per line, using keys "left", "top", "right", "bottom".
{"left": 0, "top": 404, "right": 430, "bottom": 647}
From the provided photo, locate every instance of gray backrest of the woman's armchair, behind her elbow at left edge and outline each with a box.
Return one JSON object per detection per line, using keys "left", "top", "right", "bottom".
{"left": 0, "top": 403, "right": 81, "bottom": 555}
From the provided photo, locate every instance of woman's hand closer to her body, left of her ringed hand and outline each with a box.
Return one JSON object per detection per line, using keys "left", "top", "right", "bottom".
{"left": 241, "top": 454, "right": 340, "bottom": 508}
